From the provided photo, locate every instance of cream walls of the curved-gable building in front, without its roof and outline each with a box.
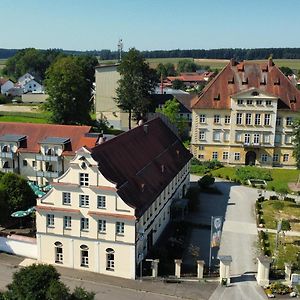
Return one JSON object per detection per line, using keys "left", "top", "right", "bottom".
{"left": 36, "top": 148, "right": 189, "bottom": 279}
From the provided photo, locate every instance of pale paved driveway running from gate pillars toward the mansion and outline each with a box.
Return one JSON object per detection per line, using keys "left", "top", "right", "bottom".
{"left": 191, "top": 175, "right": 266, "bottom": 300}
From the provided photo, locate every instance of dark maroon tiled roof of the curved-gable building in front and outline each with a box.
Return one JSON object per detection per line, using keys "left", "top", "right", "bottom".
{"left": 92, "top": 118, "right": 192, "bottom": 217}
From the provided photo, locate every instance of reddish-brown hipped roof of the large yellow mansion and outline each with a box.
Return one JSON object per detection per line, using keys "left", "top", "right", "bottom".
{"left": 193, "top": 59, "right": 300, "bottom": 111}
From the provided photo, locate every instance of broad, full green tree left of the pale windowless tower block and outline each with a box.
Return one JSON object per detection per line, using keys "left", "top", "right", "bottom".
{"left": 45, "top": 56, "right": 96, "bottom": 124}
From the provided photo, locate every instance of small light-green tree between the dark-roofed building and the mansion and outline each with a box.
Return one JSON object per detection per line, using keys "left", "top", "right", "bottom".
{"left": 156, "top": 98, "right": 187, "bottom": 136}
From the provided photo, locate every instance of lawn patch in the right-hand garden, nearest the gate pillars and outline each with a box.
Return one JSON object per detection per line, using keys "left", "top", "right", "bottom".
{"left": 269, "top": 233, "right": 300, "bottom": 269}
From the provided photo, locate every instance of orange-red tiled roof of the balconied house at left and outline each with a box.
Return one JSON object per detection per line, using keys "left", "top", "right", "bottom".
{"left": 0, "top": 122, "right": 97, "bottom": 155}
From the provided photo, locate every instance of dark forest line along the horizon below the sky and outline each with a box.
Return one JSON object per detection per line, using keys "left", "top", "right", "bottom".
{"left": 0, "top": 48, "right": 300, "bottom": 60}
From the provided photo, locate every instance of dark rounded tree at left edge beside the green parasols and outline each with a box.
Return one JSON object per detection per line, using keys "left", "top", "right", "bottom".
{"left": 0, "top": 173, "right": 36, "bottom": 222}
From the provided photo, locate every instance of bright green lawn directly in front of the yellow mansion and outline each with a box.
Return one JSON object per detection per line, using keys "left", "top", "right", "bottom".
{"left": 212, "top": 167, "right": 300, "bottom": 191}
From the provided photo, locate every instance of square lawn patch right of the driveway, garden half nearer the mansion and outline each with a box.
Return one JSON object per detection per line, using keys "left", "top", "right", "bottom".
{"left": 262, "top": 200, "right": 300, "bottom": 231}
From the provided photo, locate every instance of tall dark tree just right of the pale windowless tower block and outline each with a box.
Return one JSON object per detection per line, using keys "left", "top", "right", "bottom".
{"left": 116, "top": 48, "right": 157, "bottom": 129}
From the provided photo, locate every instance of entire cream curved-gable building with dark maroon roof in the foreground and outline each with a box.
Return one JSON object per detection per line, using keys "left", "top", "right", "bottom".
{"left": 36, "top": 119, "right": 191, "bottom": 279}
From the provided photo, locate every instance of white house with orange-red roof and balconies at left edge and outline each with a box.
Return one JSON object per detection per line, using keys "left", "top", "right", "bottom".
{"left": 0, "top": 122, "right": 99, "bottom": 186}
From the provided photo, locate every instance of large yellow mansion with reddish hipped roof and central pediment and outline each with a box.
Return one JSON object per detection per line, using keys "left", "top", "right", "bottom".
{"left": 191, "top": 59, "right": 300, "bottom": 167}
